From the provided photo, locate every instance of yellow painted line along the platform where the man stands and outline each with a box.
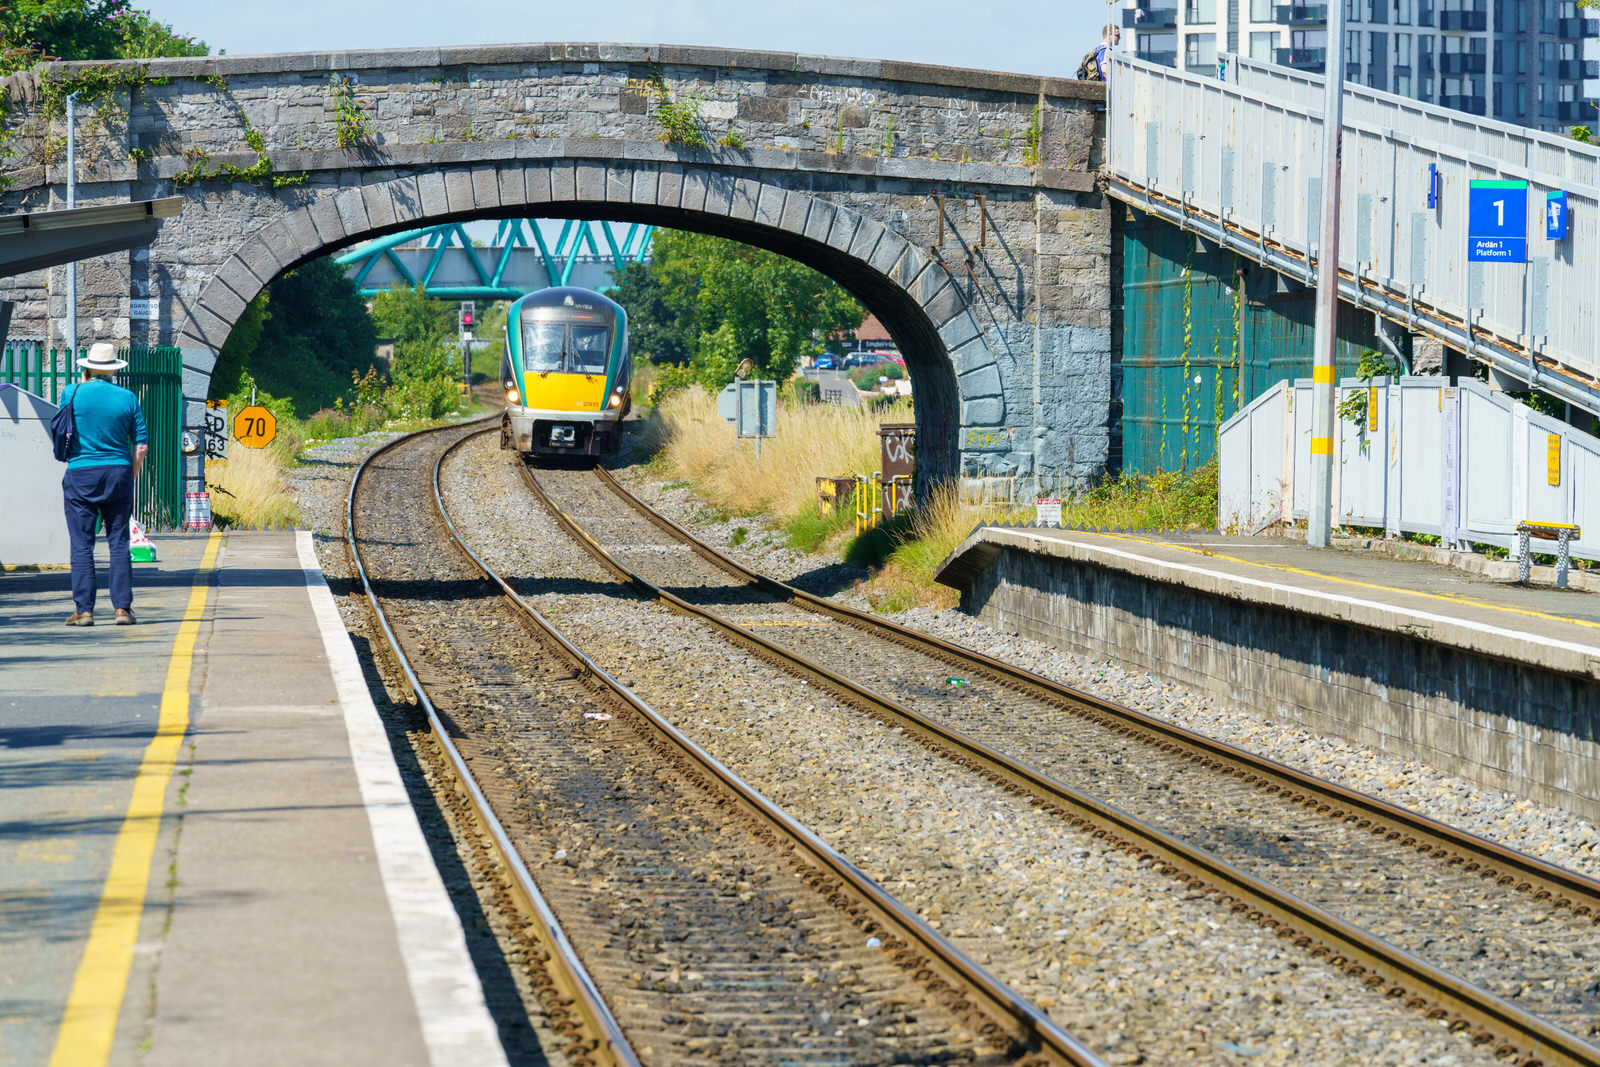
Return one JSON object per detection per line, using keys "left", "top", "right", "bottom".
{"left": 50, "top": 533, "right": 221, "bottom": 1067}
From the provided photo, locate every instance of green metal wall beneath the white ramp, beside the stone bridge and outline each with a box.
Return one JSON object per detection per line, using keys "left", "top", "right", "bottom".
{"left": 1122, "top": 208, "right": 1408, "bottom": 474}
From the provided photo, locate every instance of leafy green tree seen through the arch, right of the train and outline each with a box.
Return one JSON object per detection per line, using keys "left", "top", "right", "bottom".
{"left": 621, "top": 230, "right": 866, "bottom": 387}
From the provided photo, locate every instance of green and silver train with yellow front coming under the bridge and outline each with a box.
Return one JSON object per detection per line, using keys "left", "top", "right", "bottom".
{"left": 501, "top": 288, "right": 634, "bottom": 456}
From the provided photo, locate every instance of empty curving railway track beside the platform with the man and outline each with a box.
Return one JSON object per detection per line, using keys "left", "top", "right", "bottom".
{"left": 347, "top": 427, "right": 1101, "bottom": 1064}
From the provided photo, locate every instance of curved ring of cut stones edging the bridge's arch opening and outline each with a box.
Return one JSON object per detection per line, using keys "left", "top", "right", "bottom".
{"left": 178, "top": 158, "right": 985, "bottom": 480}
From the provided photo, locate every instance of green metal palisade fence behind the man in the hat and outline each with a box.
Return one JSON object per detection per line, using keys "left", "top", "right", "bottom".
{"left": 0, "top": 342, "right": 184, "bottom": 530}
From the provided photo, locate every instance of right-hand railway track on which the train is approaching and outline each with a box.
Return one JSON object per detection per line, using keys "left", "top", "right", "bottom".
{"left": 523, "top": 457, "right": 1600, "bottom": 1064}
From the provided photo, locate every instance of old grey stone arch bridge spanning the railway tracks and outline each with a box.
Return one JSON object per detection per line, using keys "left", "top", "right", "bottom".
{"left": 0, "top": 45, "right": 1112, "bottom": 491}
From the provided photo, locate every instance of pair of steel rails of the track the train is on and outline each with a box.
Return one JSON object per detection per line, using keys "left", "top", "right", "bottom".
{"left": 569, "top": 467, "right": 1600, "bottom": 1067}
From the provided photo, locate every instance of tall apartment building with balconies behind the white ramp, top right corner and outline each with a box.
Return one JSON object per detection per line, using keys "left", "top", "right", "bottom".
{"left": 1122, "top": 0, "right": 1600, "bottom": 131}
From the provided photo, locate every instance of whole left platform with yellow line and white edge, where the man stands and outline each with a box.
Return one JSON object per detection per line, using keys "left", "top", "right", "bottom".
{"left": 0, "top": 531, "right": 506, "bottom": 1067}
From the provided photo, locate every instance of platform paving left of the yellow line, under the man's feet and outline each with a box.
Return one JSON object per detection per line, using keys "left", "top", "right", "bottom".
{"left": 0, "top": 534, "right": 206, "bottom": 1067}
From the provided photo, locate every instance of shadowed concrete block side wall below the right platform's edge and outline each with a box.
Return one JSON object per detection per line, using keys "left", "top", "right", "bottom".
{"left": 963, "top": 547, "right": 1600, "bottom": 821}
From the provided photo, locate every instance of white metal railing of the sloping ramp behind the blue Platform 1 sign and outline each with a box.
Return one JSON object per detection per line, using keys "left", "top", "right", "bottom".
{"left": 1106, "top": 53, "right": 1600, "bottom": 413}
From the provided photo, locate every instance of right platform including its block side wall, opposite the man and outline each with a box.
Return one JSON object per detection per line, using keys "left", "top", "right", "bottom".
{"left": 938, "top": 526, "right": 1600, "bottom": 821}
